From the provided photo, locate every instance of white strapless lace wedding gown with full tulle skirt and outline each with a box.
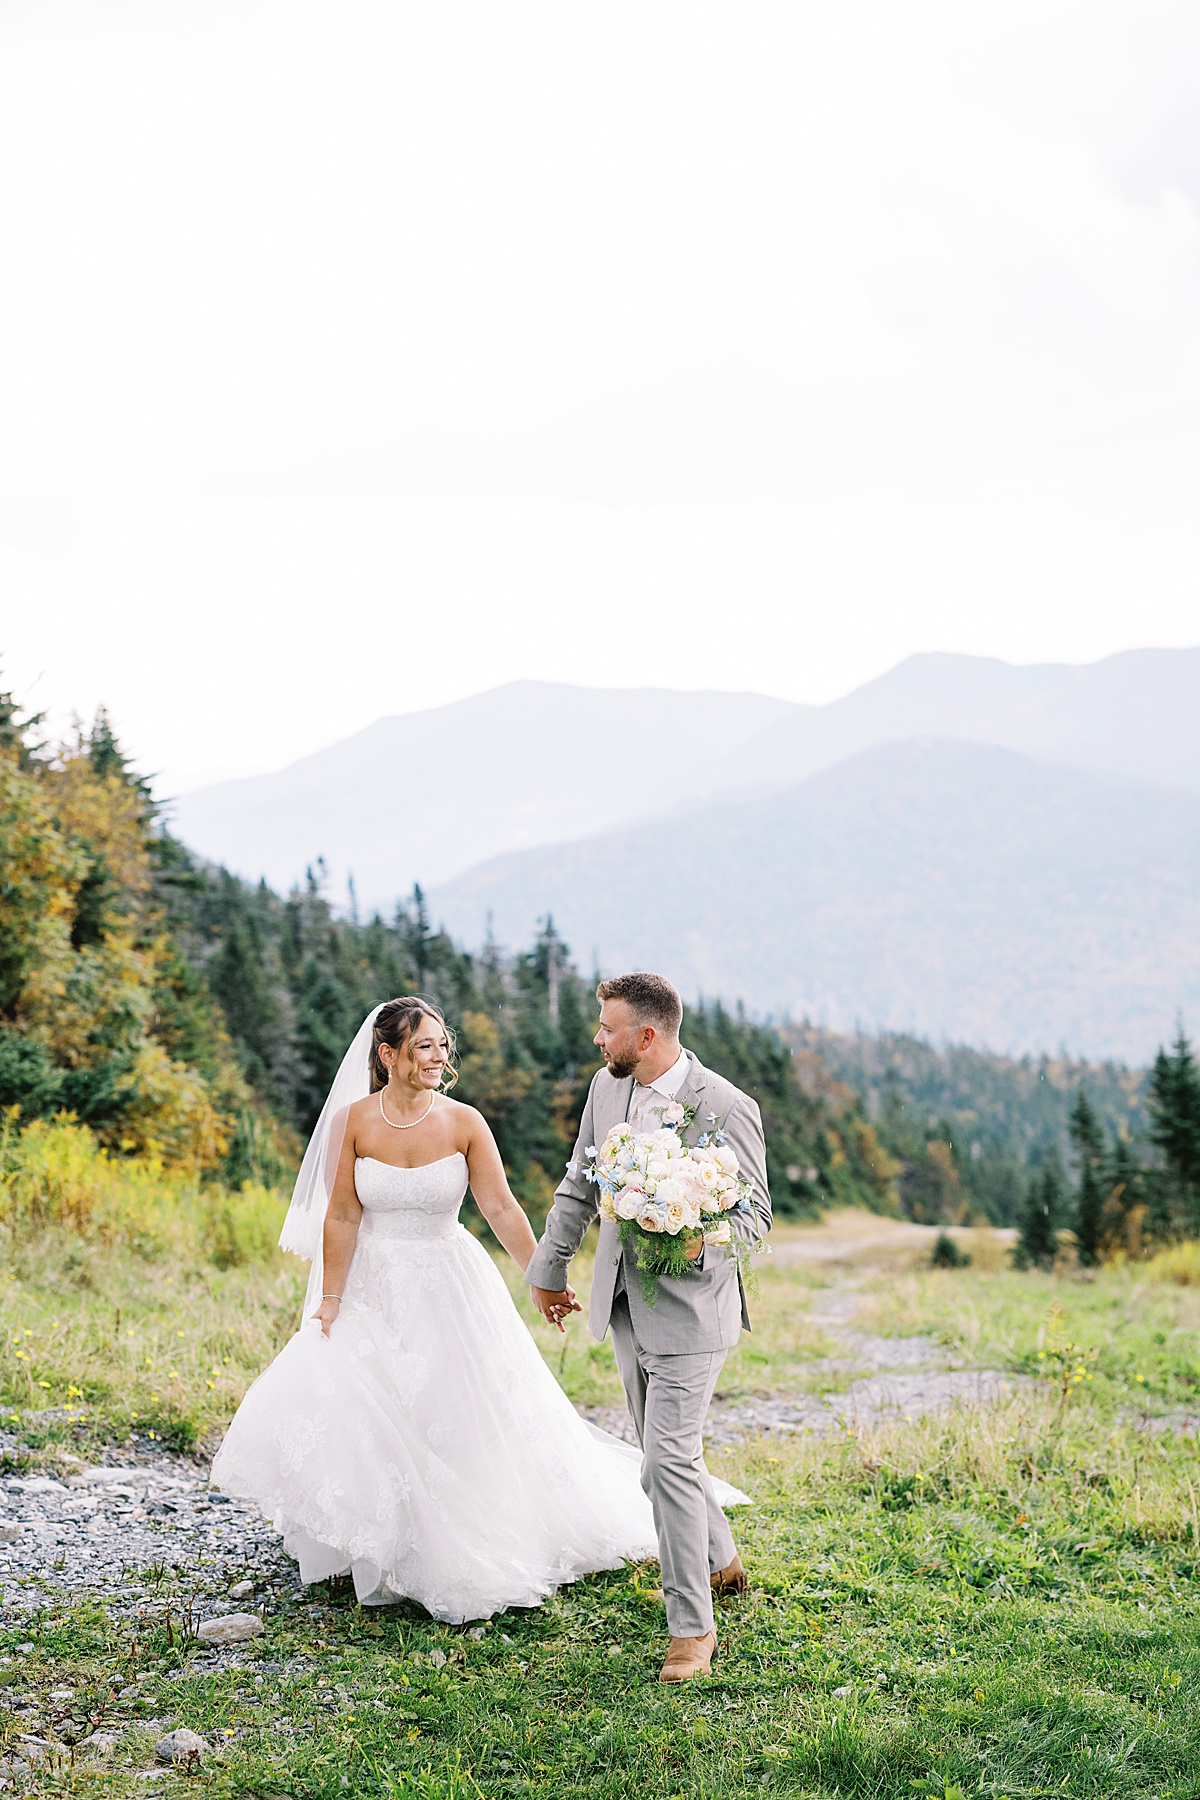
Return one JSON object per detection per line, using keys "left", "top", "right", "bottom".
{"left": 212, "top": 1154, "right": 672, "bottom": 1624}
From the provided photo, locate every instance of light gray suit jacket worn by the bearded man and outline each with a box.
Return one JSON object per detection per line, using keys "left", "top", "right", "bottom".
{"left": 525, "top": 1051, "right": 770, "bottom": 1355}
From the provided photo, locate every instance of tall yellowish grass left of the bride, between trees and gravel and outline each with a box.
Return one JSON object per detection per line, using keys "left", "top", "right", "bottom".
{"left": 0, "top": 1118, "right": 304, "bottom": 1449}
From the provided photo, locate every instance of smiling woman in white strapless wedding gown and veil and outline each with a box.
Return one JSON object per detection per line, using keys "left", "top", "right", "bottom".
{"left": 212, "top": 999, "right": 672, "bottom": 1624}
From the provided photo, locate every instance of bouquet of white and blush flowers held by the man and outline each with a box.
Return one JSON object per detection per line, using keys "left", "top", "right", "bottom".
{"left": 585, "top": 1102, "right": 752, "bottom": 1307}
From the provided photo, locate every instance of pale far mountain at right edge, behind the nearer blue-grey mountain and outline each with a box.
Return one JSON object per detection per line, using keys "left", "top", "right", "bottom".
{"left": 707, "top": 650, "right": 1200, "bottom": 794}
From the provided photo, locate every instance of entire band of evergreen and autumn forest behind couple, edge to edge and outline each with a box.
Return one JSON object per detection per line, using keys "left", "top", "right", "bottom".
{"left": 0, "top": 676, "right": 1200, "bottom": 1258}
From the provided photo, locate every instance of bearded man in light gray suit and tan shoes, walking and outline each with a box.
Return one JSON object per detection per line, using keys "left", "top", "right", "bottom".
{"left": 525, "top": 974, "right": 770, "bottom": 1681}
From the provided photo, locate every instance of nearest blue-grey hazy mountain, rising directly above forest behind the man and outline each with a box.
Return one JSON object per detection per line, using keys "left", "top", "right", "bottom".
{"left": 434, "top": 742, "right": 1200, "bottom": 1060}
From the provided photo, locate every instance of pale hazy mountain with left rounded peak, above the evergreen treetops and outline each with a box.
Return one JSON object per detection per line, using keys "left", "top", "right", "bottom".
{"left": 173, "top": 682, "right": 795, "bottom": 907}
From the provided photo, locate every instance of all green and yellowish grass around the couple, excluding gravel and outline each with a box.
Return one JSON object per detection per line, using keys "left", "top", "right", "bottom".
{"left": 0, "top": 1195, "right": 1200, "bottom": 1800}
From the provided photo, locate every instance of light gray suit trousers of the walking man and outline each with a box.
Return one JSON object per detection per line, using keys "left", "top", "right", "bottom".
{"left": 612, "top": 1292, "right": 738, "bottom": 1638}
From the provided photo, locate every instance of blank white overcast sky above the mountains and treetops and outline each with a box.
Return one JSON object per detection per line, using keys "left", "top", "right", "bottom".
{"left": 0, "top": 0, "right": 1200, "bottom": 790}
